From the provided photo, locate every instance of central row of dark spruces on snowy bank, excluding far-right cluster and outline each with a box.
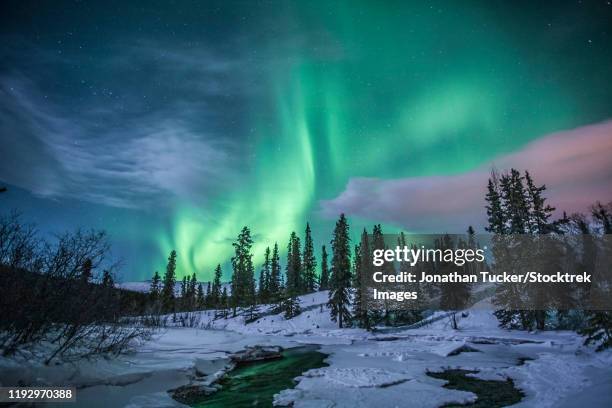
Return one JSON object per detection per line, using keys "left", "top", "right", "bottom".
{"left": 149, "top": 214, "right": 474, "bottom": 330}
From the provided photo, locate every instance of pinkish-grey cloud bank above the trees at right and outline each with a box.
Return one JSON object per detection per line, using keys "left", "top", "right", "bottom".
{"left": 320, "top": 121, "right": 612, "bottom": 232}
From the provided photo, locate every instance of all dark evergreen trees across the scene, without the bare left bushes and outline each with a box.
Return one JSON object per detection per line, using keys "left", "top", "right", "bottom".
{"left": 3, "top": 169, "right": 612, "bottom": 350}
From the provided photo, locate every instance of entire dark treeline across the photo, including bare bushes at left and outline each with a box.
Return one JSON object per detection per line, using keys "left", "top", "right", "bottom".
{"left": 0, "top": 169, "right": 612, "bottom": 356}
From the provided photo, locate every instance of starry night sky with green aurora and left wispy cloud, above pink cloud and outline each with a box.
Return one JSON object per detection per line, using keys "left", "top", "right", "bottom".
{"left": 0, "top": 1, "right": 612, "bottom": 280}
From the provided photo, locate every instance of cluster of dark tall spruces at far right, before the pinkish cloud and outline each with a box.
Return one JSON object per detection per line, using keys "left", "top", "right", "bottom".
{"left": 485, "top": 169, "right": 612, "bottom": 350}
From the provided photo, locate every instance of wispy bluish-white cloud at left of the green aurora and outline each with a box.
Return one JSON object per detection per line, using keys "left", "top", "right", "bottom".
{"left": 0, "top": 75, "right": 234, "bottom": 208}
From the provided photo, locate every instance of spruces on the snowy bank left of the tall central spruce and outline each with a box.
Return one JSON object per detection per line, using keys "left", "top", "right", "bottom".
{"left": 149, "top": 223, "right": 330, "bottom": 318}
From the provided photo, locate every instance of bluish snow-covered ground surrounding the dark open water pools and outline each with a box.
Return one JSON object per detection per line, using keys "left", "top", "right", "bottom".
{"left": 0, "top": 292, "right": 612, "bottom": 408}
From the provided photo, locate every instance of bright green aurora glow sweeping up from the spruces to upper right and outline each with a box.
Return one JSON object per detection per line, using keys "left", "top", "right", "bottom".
{"left": 159, "top": 2, "right": 604, "bottom": 273}
